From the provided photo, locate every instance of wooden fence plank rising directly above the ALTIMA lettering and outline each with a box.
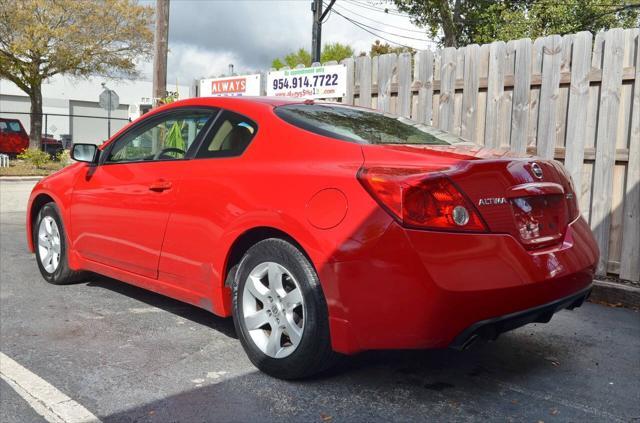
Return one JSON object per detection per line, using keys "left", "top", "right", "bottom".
{"left": 484, "top": 41, "right": 506, "bottom": 148}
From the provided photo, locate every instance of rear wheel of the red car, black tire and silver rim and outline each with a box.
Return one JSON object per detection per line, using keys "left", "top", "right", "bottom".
{"left": 233, "top": 238, "right": 338, "bottom": 379}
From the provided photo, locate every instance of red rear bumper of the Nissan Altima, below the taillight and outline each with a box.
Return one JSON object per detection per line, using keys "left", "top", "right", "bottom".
{"left": 320, "top": 218, "right": 598, "bottom": 353}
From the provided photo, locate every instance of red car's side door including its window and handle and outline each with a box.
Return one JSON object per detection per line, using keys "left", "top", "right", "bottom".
{"left": 70, "top": 109, "right": 217, "bottom": 278}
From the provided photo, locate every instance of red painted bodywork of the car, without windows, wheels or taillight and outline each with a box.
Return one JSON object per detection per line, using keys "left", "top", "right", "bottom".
{"left": 27, "top": 98, "right": 598, "bottom": 353}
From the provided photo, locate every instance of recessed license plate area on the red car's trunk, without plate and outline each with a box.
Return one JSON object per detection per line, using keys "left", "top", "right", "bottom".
{"left": 510, "top": 194, "right": 569, "bottom": 248}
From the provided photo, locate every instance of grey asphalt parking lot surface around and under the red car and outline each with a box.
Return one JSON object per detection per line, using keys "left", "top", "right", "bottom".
{"left": 0, "top": 181, "right": 640, "bottom": 422}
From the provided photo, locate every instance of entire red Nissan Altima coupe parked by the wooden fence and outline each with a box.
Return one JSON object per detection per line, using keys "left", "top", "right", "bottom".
{"left": 27, "top": 98, "right": 598, "bottom": 379}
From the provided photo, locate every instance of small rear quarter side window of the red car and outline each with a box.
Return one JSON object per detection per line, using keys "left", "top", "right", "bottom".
{"left": 196, "top": 110, "right": 258, "bottom": 158}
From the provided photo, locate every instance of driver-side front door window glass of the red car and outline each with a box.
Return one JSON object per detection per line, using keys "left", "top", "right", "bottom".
{"left": 106, "top": 110, "right": 217, "bottom": 163}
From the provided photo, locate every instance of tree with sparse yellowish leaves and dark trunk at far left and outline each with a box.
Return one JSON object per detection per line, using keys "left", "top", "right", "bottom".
{"left": 0, "top": 0, "right": 153, "bottom": 148}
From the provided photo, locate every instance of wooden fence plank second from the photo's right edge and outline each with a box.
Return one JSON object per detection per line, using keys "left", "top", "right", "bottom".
{"left": 591, "top": 28, "right": 624, "bottom": 275}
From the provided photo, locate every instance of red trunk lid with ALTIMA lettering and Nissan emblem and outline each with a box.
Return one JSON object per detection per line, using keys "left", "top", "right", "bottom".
{"left": 363, "top": 144, "right": 578, "bottom": 249}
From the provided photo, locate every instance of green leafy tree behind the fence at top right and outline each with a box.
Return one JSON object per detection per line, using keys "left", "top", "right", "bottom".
{"left": 389, "top": 0, "right": 640, "bottom": 47}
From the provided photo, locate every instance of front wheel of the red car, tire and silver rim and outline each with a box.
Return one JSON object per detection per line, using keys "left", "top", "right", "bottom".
{"left": 33, "top": 202, "right": 85, "bottom": 285}
